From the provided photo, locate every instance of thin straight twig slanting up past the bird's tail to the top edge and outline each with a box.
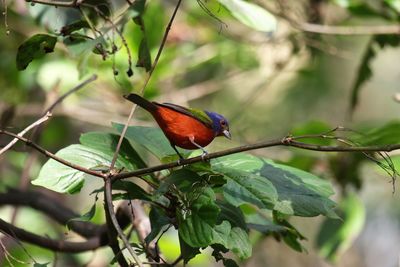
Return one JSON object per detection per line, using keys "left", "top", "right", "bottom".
{"left": 110, "top": 0, "right": 182, "bottom": 169}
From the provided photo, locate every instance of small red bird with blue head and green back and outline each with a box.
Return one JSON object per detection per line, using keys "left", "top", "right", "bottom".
{"left": 124, "top": 94, "right": 231, "bottom": 158}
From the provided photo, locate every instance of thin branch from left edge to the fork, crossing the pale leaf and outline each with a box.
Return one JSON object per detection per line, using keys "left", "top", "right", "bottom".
{"left": 0, "top": 130, "right": 105, "bottom": 178}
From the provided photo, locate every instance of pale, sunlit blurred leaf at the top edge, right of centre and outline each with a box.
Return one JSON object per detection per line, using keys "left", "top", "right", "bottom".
{"left": 218, "top": 0, "right": 277, "bottom": 32}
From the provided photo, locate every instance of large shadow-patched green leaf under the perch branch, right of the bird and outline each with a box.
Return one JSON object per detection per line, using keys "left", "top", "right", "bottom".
{"left": 212, "top": 154, "right": 336, "bottom": 217}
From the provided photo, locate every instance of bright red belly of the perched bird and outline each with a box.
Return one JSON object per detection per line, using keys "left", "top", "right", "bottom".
{"left": 153, "top": 108, "right": 215, "bottom": 149}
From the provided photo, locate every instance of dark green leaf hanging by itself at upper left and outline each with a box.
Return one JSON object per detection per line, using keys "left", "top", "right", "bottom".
{"left": 16, "top": 34, "right": 57, "bottom": 70}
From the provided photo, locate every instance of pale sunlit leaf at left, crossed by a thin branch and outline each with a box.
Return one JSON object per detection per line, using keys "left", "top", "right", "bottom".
{"left": 32, "top": 144, "right": 126, "bottom": 194}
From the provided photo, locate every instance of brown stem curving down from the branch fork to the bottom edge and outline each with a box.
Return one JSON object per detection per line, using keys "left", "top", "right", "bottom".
{"left": 104, "top": 177, "right": 143, "bottom": 267}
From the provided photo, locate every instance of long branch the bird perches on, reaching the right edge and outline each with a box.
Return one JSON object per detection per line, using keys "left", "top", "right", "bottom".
{"left": 112, "top": 136, "right": 400, "bottom": 181}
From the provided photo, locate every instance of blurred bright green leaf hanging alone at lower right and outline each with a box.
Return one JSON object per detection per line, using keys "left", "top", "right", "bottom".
{"left": 316, "top": 194, "right": 365, "bottom": 262}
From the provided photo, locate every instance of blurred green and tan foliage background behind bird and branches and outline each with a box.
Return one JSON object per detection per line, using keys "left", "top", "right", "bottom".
{"left": 0, "top": 0, "right": 400, "bottom": 267}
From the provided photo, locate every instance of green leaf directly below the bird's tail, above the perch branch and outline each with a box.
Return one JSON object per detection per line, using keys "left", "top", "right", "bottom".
{"left": 113, "top": 123, "right": 190, "bottom": 160}
